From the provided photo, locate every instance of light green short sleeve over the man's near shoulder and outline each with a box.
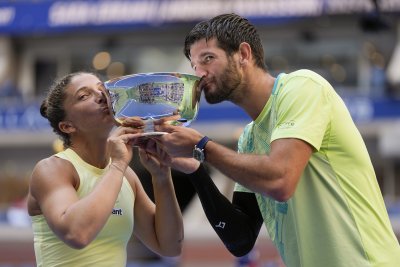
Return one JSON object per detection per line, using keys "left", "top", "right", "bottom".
{"left": 271, "top": 76, "right": 331, "bottom": 151}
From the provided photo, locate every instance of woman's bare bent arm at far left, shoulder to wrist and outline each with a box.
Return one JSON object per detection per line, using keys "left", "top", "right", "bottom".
{"left": 30, "top": 156, "right": 123, "bottom": 249}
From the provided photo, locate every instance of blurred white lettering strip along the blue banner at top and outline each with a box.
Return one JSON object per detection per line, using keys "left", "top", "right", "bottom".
{"left": 46, "top": 0, "right": 400, "bottom": 27}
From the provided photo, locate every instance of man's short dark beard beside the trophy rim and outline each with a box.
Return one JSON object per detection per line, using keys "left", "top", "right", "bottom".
{"left": 204, "top": 59, "right": 241, "bottom": 104}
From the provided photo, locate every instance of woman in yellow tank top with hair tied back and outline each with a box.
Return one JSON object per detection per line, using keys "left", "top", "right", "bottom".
{"left": 28, "top": 73, "right": 183, "bottom": 267}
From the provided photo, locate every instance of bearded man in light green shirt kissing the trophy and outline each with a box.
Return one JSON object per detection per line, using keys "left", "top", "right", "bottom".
{"left": 154, "top": 14, "right": 400, "bottom": 267}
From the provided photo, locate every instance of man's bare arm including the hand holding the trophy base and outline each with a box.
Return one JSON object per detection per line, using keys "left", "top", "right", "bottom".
{"left": 158, "top": 124, "right": 313, "bottom": 201}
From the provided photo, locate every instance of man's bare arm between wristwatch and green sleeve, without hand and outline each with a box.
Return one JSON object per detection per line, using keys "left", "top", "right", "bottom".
{"left": 205, "top": 138, "right": 313, "bottom": 202}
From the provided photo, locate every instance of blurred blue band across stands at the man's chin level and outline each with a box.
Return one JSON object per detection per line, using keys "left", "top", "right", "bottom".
{"left": 0, "top": 97, "right": 400, "bottom": 131}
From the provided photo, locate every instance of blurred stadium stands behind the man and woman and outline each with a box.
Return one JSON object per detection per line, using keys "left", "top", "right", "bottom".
{"left": 0, "top": 0, "right": 400, "bottom": 267}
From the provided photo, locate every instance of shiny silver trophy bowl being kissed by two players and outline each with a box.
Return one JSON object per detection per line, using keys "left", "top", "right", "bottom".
{"left": 104, "top": 72, "right": 201, "bottom": 135}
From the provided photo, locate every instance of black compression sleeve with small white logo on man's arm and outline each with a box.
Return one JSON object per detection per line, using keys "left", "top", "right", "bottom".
{"left": 189, "top": 165, "right": 263, "bottom": 257}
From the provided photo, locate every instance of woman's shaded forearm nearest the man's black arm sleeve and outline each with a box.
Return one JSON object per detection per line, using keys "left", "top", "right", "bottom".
{"left": 128, "top": 143, "right": 183, "bottom": 256}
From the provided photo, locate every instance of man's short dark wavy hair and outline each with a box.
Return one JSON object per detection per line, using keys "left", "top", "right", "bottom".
{"left": 184, "top": 14, "right": 267, "bottom": 70}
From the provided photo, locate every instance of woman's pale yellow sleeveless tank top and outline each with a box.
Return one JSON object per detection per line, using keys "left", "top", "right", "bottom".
{"left": 32, "top": 149, "right": 135, "bottom": 267}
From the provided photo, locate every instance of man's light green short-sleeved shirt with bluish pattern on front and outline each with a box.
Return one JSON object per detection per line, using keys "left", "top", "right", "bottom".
{"left": 235, "top": 70, "right": 400, "bottom": 267}
